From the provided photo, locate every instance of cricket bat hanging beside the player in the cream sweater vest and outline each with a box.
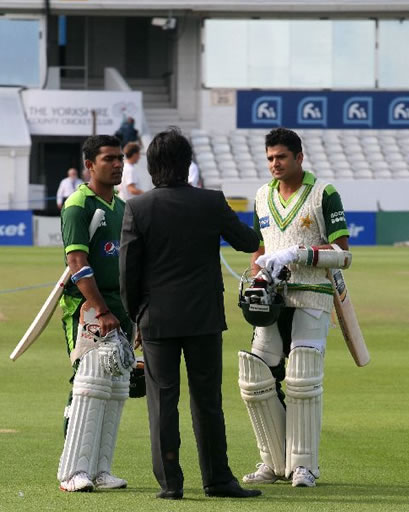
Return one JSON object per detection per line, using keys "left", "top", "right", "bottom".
{"left": 328, "top": 269, "right": 371, "bottom": 366}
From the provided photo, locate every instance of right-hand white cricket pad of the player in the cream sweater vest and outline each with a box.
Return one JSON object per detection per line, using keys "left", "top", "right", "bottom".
{"left": 285, "top": 347, "right": 324, "bottom": 478}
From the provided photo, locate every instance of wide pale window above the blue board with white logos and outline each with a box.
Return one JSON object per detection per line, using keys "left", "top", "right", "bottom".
{"left": 204, "top": 19, "right": 376, "bottom": 89}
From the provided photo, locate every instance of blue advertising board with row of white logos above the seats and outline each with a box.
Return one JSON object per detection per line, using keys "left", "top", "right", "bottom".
{"left": 236, "top": 91, "right": 409, "bottom": 129}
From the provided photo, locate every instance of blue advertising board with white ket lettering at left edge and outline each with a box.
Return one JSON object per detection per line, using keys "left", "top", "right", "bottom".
{"left": 0, "top": 210, "right": 33, "bottom": 245}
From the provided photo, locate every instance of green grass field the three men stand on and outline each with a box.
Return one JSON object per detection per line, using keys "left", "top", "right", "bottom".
{"left": 0, "top": 247, "right": 409, "bottom": 512}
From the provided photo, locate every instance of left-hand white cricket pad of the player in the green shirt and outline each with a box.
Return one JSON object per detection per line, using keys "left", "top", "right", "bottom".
{"left": 57, "top": 350, "right": 112, "bottom": 482}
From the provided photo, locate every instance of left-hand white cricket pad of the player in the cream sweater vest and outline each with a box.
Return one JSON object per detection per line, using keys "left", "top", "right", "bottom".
{"left": 239, "top": 350, "right": 285, "bottom": 476}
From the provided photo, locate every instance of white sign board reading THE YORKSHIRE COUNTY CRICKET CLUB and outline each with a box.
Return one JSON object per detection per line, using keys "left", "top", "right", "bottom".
{"left": 22, "top": 89, "right": 142, "bottom": 136}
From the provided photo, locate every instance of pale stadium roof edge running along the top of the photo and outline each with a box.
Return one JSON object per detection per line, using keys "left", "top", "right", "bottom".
{"left": 0, "top": 0, "right": 409, "bottom": 16}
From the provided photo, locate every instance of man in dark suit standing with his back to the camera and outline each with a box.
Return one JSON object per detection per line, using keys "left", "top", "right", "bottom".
{"left": 120, "top": 129, "right": 261, "bottom": 499}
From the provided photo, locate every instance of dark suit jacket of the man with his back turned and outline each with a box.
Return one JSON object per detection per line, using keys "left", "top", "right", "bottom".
{"left": 120, "top": 184, "right": 259, "bottom": 339}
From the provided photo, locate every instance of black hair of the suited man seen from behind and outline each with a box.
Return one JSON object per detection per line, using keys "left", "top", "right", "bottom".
{"left": 146, "top": 126, "right": 192, "bottom": 187}
